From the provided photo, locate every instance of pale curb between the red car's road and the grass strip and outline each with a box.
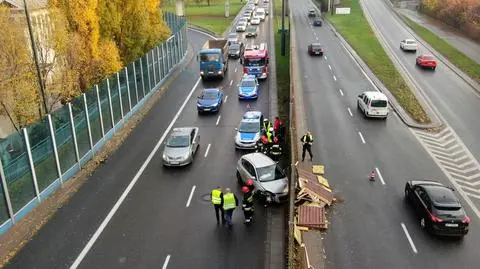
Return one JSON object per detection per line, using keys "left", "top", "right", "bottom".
{"left": 385, "top": 0, "right": 480, "bottom": 93}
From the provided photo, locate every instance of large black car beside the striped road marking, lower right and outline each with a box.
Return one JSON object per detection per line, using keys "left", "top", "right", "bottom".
{"left": 405, "top": 180, "right": 470, "bottom": 237}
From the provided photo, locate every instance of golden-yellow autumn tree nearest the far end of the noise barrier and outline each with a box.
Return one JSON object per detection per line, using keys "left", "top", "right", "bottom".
{"left": 98, "top": 0, "right": 170, "bottom": 64}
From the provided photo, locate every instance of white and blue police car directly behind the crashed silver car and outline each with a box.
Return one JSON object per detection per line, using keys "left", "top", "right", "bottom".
{"left": 235, "top": 111, "right": 263, "bottom": 149}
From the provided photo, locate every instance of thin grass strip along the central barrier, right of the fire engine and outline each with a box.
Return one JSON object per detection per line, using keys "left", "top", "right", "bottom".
{"left": 271, "top": 1, "right": 290, "bottom": 119}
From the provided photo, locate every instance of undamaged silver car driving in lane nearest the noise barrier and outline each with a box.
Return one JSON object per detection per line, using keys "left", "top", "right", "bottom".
{"left": 163, "top": 127, "right": 200, "bottom": 166}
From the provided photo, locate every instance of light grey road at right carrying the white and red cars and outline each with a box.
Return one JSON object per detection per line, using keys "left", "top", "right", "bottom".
{"left": 362, "top": 0, "right": 480, "bottom": 159}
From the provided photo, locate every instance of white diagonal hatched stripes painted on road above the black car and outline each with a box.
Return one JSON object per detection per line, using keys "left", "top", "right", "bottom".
{"left": 412, "top": 127, "right": 480, "bottom": 199}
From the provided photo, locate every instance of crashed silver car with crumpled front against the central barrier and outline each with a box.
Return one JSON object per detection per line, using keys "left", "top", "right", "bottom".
{"left": 237, "top": 152, "right": 288, "bottom": 203}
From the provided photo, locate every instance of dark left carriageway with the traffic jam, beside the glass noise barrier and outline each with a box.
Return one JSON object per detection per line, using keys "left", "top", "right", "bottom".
{"left": 3, "top": 11, "right": 281, "bottom": 269}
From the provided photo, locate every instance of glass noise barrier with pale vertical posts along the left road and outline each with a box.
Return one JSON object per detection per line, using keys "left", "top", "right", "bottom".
{"left": 0, "top": 12, "right": 188, "bottom": 235}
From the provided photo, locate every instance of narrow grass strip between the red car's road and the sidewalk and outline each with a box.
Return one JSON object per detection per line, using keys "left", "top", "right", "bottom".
{"left": 402, "top": 16, "right": 480, "bottom": 82}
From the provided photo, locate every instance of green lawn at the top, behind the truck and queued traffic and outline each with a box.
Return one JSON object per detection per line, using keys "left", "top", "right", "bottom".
{"left": 163, "top": 0, "right": 246, "bottom": 35}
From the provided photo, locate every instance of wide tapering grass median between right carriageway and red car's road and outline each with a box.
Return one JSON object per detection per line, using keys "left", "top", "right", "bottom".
{"left": 327, "top": 0, "right": 431, "bottom": 123}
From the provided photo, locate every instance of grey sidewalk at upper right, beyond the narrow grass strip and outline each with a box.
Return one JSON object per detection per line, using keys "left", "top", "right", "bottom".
{"left": 396, "top": 8, "right": 480, "bottom": 64}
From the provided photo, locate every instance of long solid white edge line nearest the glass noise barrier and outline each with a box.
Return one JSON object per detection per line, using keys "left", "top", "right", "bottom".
{"left": 70, "top": 78, "right": 201, "bottom": 269}
